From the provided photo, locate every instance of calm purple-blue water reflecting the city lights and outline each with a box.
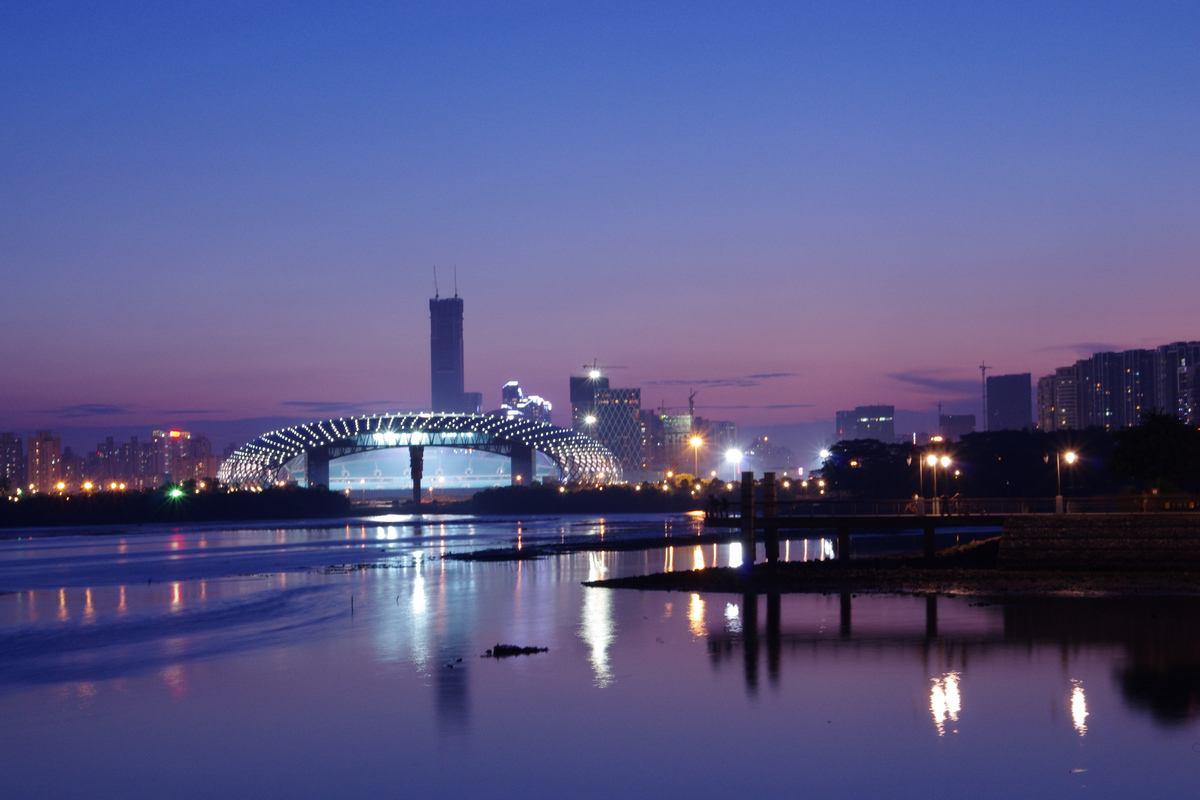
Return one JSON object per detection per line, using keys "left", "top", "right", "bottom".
{"left": 0, "top": 517, "right": 1200, "bottom": 798}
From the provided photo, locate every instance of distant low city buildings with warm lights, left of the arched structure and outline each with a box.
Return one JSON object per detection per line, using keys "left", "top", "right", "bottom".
{"left": 0, "top": 429, "right": 220, "bottom": 492}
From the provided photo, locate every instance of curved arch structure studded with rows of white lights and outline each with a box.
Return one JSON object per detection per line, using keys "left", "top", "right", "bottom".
{"left": 217, "top": 411, "right": 620, "bottom": 499}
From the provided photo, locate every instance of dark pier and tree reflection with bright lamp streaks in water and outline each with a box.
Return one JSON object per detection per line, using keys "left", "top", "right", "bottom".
{"left": 708, "top": 594, "right": 1200, "bottom": 736}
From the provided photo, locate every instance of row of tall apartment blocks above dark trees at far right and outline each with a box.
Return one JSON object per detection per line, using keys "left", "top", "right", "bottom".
{"left": 1037, "top": 342, "right": 1200, "bottom": 431}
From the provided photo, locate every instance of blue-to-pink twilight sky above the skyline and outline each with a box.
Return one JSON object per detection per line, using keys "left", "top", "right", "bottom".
{"left": 0, "top": 2, "right": 1200, "bottom": 443}
